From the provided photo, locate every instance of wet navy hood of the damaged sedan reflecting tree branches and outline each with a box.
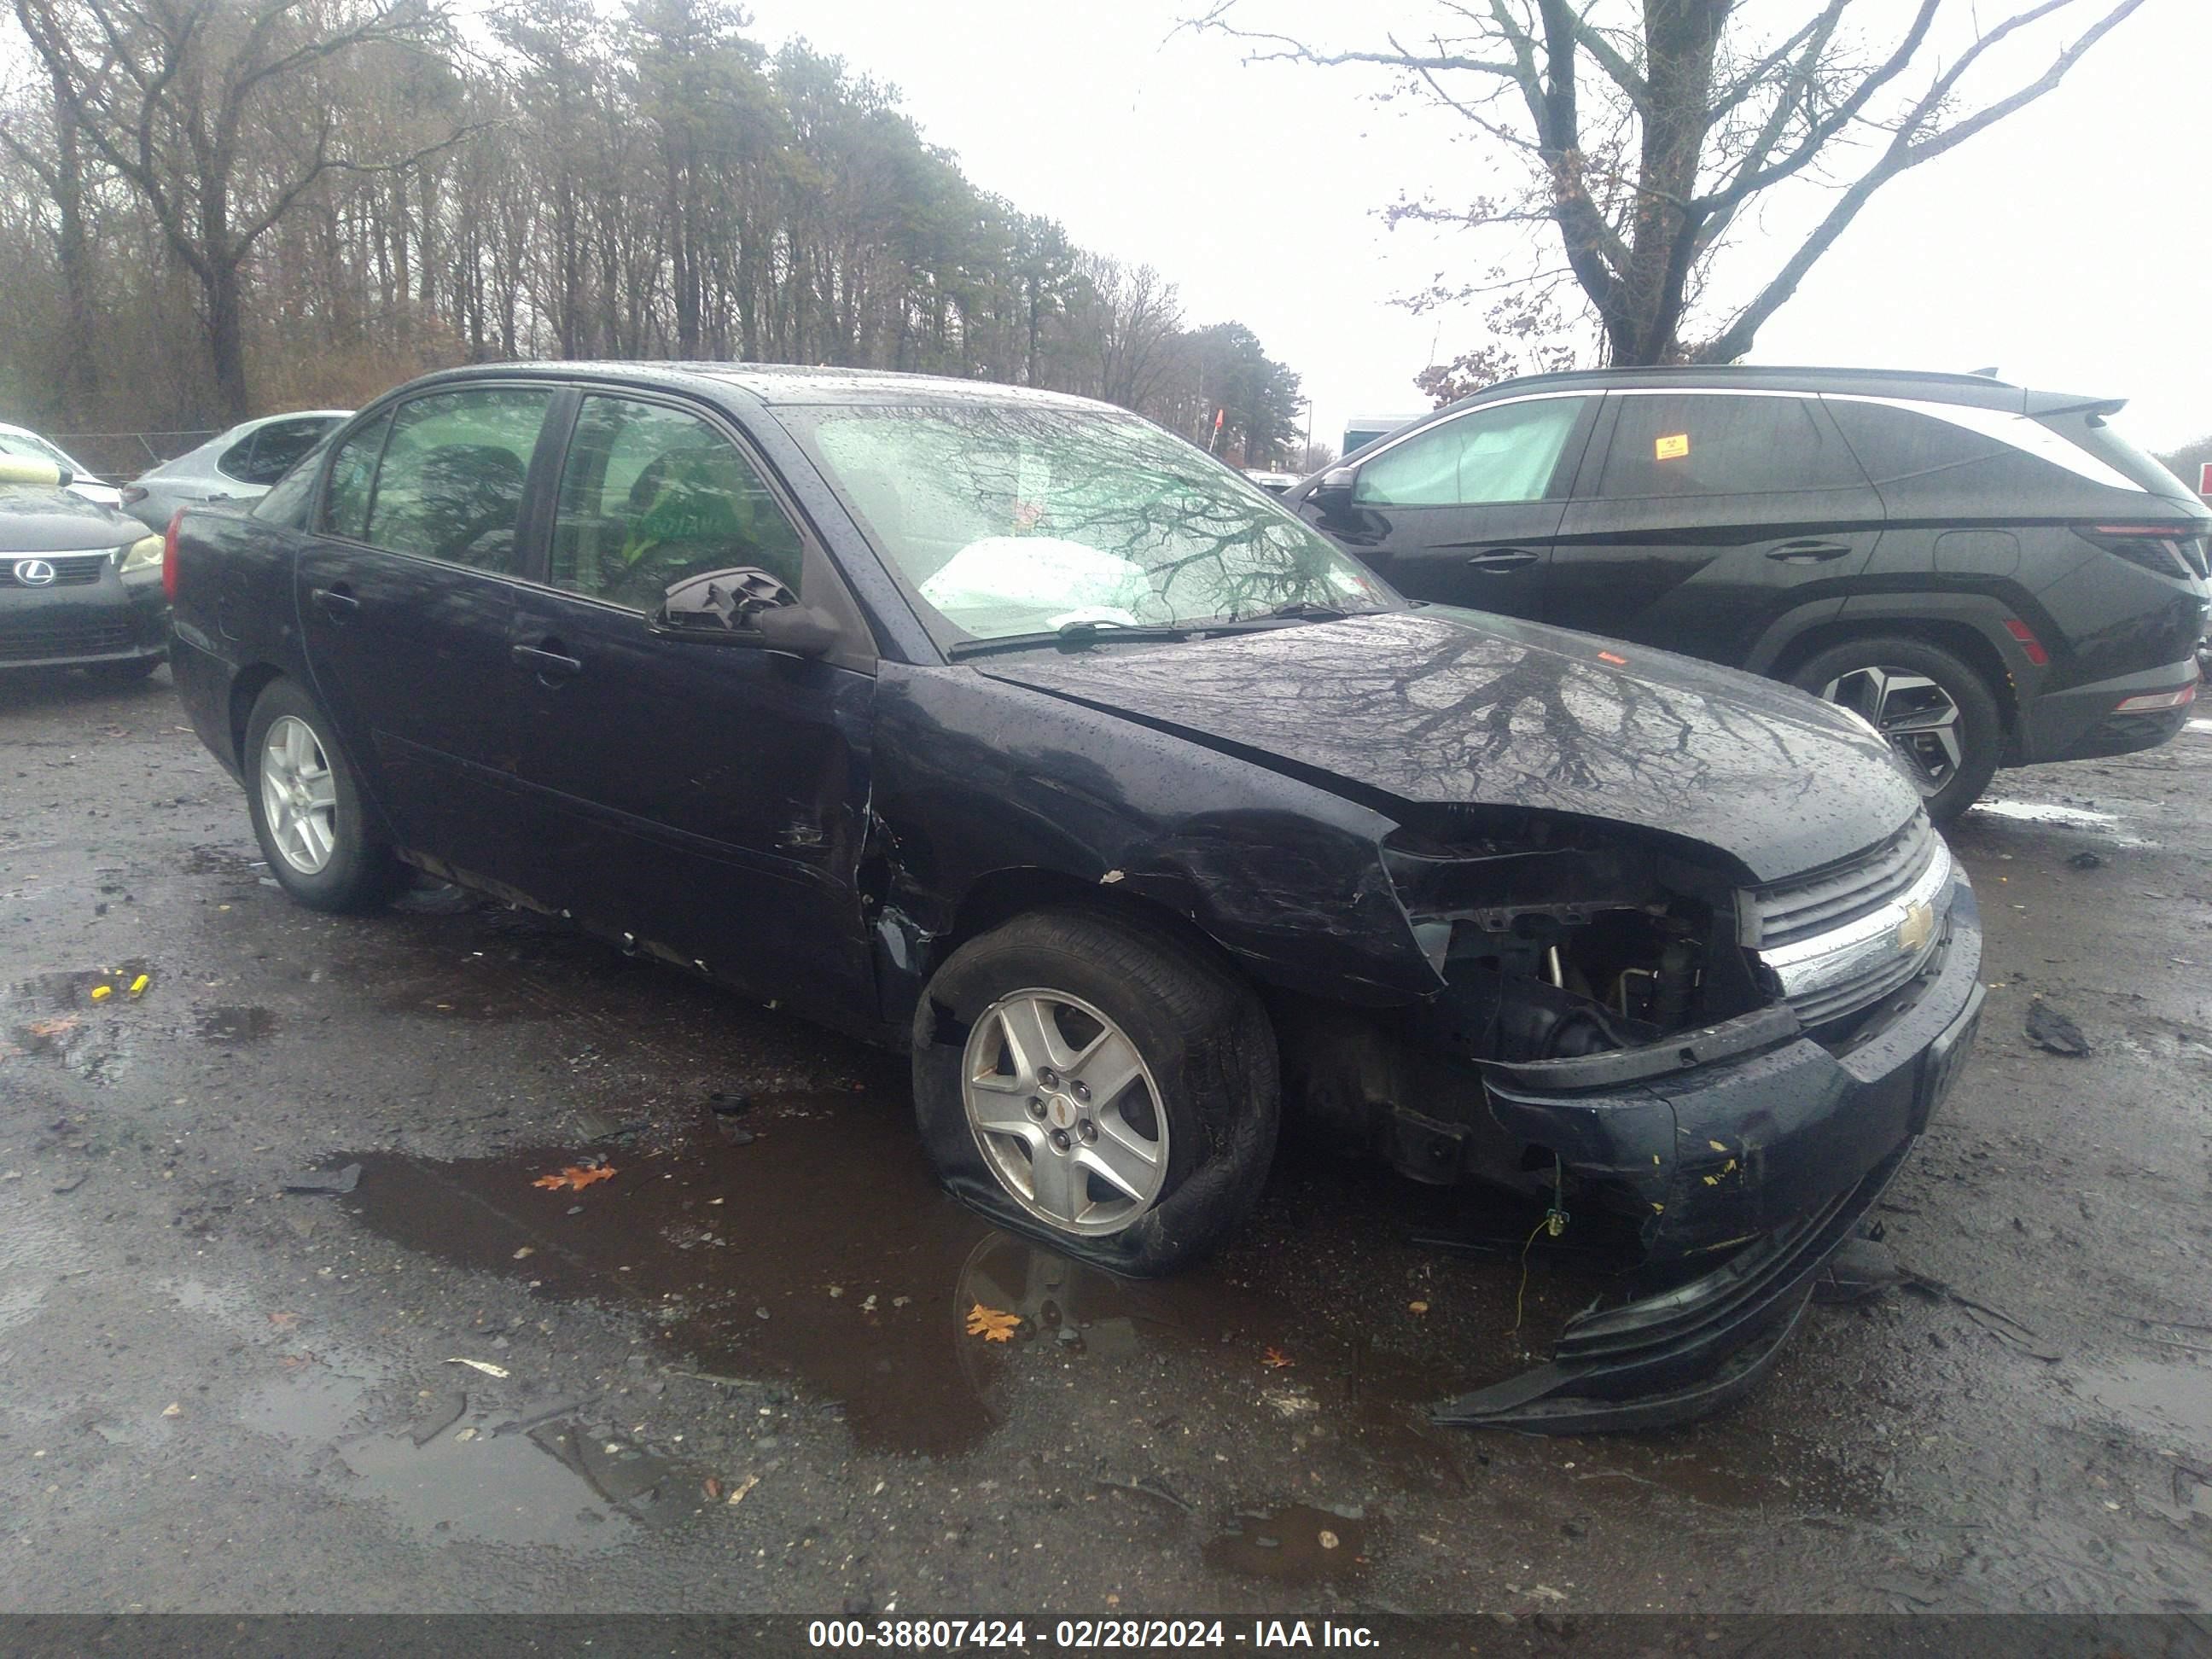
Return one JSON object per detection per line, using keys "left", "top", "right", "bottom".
{"left": 975, "top": 606, "right": 1920, "bottom": 882}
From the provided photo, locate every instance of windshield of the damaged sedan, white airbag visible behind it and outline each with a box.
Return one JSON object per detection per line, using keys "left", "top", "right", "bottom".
{"left": 783, "top": 405, "right": 1396, "bottom": 639}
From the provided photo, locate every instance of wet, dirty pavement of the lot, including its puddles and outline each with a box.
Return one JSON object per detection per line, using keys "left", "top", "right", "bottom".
{"left": 0, "top": 675, "right": 2212, "bottom": 1615}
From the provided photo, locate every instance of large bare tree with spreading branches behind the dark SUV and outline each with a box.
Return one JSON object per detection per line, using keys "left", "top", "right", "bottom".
{"left": 1188, "top": 0, "right": 2144, "bottom": 363}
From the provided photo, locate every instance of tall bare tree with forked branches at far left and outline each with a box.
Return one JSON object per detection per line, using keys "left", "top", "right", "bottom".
{"left": 14, "top": 0, "right": 477, "bottom": 420}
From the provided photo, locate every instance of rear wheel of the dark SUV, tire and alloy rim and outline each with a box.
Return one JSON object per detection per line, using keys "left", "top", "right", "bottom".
{"left": 1790, "top": 635, "right": 2004, "bottom": 823}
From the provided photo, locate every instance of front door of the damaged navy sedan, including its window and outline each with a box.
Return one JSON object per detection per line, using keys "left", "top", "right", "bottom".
{"left": 511, "top": 392, "right": 876, "bottom": 1017}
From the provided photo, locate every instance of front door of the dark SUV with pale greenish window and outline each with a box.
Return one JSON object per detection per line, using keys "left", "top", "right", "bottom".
{"left": 1301, "top": 393, "right": 1599, "bottom": 617}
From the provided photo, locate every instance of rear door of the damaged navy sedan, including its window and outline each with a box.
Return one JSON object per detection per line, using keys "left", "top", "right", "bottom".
{"left": 294, "top": 385, "right": 557, "bottom": 892}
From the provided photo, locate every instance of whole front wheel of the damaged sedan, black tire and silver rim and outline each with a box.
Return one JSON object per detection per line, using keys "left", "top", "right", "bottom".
{"left": 913, "top": 909, "right": 1281, "bottom": 1277}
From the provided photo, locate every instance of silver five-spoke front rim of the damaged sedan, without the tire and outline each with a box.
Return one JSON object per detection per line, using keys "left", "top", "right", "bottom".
{"left": 960, "top": 989, "right": 1168, "bottom": 1237}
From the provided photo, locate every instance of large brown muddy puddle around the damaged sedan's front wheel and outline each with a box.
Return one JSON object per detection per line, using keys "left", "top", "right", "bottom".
{"left": 327, "top": 1095, "right": 1878, "bottom": 1522}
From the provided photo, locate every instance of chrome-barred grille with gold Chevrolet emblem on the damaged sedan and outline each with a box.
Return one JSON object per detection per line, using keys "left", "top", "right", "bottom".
{"left": 1749, "top": 816, "right": 1955, "bottom": 1027}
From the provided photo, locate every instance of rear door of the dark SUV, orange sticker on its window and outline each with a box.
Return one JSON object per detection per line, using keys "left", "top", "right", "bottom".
{"left": 1544, "top": 389, "right": 1883, "bottom": 666}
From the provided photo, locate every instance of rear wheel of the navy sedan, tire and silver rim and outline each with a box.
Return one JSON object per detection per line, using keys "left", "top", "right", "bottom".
{"left": 243, "top": 679, "right": 407, "bottom": 911}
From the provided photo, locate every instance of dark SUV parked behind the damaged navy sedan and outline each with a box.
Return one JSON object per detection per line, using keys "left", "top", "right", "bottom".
{"left": 1285, "top": 367, "right": 2212, "bottom": 818}
